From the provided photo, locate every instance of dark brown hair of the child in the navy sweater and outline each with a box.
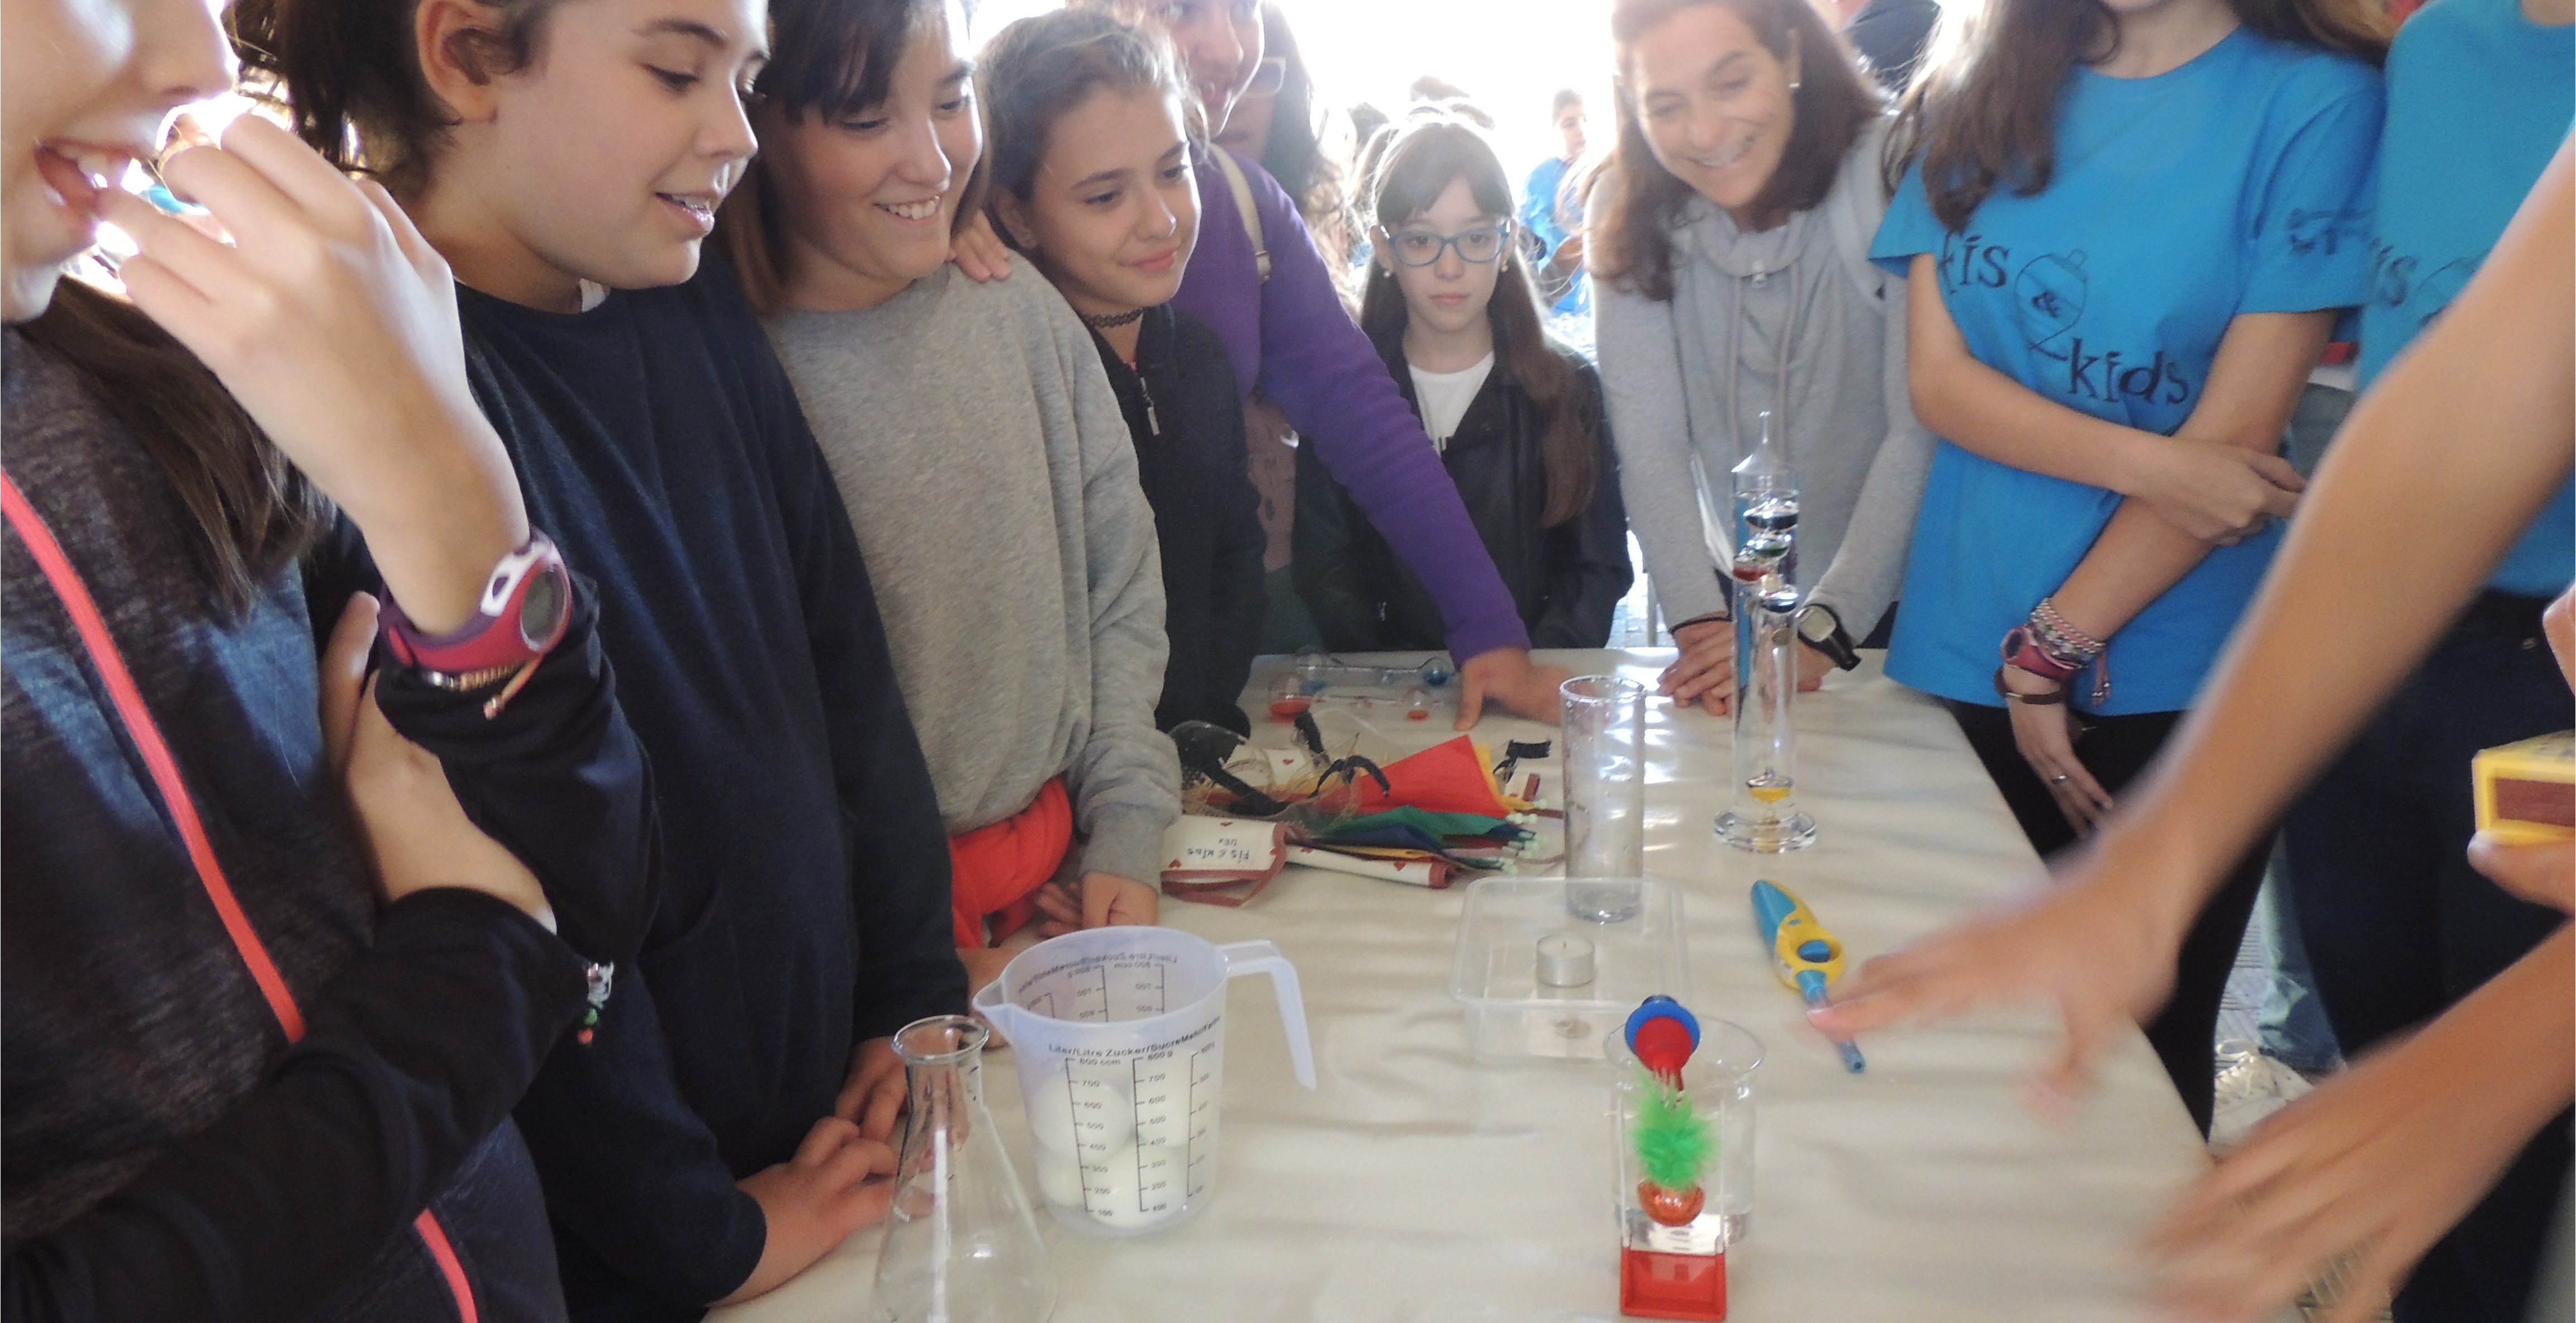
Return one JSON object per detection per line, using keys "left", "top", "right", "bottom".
{"left": 227, "top": 0, "right": 562, "bottom": 198}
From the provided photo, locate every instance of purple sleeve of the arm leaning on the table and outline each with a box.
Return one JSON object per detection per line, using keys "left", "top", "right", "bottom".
{"left": 1180, "top": 157, "right": 1530, "bottom": 662}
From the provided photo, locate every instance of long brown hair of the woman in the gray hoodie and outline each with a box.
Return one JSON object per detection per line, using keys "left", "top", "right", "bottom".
{"left": 1584, "top": 0, "right": 1875, "bottom": 301}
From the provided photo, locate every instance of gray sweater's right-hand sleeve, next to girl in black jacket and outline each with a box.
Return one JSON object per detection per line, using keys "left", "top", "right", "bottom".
{"left": 1048, "top": 298, "right": 1180, "bottom": 886}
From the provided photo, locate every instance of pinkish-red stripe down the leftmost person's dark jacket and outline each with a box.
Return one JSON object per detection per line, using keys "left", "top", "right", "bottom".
{"left": 0, "top": 471, "right": 482, "bottom": 1323}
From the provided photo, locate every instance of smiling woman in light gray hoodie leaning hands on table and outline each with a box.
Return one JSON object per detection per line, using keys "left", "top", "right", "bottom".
{"left": 1589, "top": 0, "right": 1932, "bottom": 713}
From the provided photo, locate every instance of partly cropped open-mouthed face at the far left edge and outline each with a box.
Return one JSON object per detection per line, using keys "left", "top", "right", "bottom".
{"left": 0, "top": 0, "right": 232, "bottom": 322}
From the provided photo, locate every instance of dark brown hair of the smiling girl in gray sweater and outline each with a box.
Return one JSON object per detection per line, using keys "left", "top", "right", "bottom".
{"left": 716, "top": 0, "right": 992, "bottom": 314}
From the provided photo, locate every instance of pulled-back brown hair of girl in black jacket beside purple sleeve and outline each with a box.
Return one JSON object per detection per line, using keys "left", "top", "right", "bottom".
{"left": 974, "top": 10, "right": 1198, "bottom": 242}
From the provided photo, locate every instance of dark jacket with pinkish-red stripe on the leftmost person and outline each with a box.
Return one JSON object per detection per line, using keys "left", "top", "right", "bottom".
{"left": 0, "top": 321, "right": 654, "bottom": 1323}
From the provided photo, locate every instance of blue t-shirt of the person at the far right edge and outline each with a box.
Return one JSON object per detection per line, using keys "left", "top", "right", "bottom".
{"left": 2362, "top": 0, "right": 2576, "bottom": 597}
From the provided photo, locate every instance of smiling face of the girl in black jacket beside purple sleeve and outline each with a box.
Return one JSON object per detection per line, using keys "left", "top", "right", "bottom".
{"left": 1000, "top": 88, "right": 1198, "bottom": 317}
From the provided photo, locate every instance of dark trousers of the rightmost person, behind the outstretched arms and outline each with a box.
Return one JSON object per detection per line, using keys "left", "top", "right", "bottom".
{"left": 2285, "top": 592, "right": 2576, "bottom": 1323}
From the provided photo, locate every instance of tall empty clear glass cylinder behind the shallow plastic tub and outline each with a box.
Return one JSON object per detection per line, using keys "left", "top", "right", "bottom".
{"left": 1558, "top": 674, "right": 1646, "bottom": 924}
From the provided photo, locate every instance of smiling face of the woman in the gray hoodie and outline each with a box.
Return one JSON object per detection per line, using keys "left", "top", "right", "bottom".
{"left": 1626, "top": 5, "right": 1798, "bottom": 229}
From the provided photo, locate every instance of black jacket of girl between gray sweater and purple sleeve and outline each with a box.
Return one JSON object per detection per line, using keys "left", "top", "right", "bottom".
{"left": 1092, "top": 304, "right": 1265, "bottom": 734}
